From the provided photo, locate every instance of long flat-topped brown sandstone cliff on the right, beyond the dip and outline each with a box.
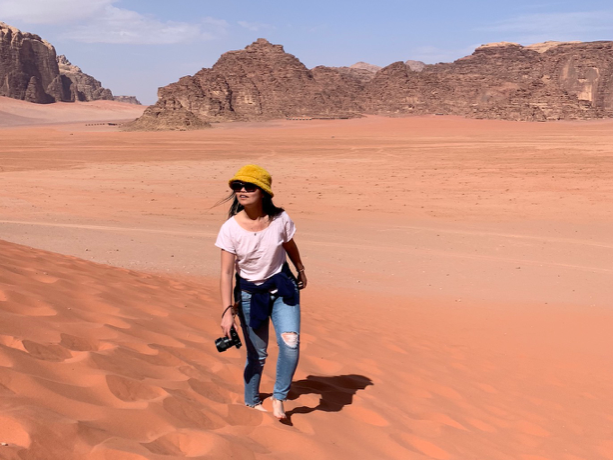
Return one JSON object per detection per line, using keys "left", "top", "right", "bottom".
{"left": 362, "top": 42, "right": 613, "bottom": 121}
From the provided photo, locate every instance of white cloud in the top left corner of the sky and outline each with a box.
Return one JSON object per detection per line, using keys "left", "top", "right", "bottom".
{"left": 0, "top": 0, "right": 117, "bottom": 24}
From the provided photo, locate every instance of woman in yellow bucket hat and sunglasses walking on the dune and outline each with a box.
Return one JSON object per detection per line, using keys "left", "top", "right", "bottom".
{"left": 215, "top": 165, "right": 307, "bottom": 419}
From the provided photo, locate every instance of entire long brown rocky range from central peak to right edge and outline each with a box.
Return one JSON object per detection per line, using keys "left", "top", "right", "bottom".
{"left": 131, "top": 39, "right": 613, "bottom": 128}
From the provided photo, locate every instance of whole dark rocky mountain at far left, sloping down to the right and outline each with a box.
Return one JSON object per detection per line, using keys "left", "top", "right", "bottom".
{"left": 0, "top": 22, "right": 118, "bottom": 104}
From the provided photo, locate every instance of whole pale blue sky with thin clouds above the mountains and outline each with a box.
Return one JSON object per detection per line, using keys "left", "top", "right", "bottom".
{"left": 0, "top": 0, "right": 613, "bottom": 104}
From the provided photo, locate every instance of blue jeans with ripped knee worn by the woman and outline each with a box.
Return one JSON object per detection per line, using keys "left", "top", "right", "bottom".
{"left": 239, "top": 291, "right": 300, "bottom": 407}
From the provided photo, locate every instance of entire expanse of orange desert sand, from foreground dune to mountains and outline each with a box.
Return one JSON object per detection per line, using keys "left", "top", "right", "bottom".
{"left": 0, "top": 100, "right": 613, "bottom": 460}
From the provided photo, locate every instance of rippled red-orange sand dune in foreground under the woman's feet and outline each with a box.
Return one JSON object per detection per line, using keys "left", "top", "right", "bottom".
{"left": 0, "top": 243, "right": 613, "bottom": 459}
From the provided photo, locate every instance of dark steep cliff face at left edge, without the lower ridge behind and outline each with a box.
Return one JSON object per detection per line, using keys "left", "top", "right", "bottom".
{"left": 0, "top": 22, "right": 60, "bottom": 104}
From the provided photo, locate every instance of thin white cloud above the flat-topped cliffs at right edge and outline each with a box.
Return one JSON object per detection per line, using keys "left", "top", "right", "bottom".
{"left": 478, "top": 11, "right": 613, "bottom": 43}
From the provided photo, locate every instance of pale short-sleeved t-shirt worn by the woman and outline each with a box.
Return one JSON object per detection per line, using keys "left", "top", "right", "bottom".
{"left": 215, "top": 211, "right": 296, "bottom": 284}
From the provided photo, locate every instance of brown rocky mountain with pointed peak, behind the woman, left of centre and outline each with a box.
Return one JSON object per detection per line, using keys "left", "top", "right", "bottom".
{"left": 125, "top": 39, "right": 362, "bottom": 130}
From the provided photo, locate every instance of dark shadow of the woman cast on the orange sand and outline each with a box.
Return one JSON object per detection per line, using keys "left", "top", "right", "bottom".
{"left": 262, "top": 374, "right": 374, "bottom": 425}
